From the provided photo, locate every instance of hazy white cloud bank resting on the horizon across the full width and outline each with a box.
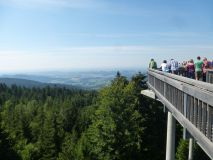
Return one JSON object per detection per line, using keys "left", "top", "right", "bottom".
{"left": 0, "top": 45, "right": 213, "bottom": 72}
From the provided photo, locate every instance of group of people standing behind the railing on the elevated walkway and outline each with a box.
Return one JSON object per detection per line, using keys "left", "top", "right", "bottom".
{"left": 149, "top": 56, "right": 213, "bottom": 82}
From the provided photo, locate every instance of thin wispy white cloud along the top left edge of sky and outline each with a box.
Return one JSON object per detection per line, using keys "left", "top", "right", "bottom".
{"left": 0, "top": 0, "right": 161, "bottom": 17}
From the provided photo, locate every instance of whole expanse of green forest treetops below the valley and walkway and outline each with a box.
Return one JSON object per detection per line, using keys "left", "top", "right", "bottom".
{"left": 0, "top": 72, "right": 174, "bottom": 160}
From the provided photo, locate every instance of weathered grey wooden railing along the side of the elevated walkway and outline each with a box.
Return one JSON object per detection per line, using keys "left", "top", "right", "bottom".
{"left": 148, "top": 69, "right": 213, "bottom": 159}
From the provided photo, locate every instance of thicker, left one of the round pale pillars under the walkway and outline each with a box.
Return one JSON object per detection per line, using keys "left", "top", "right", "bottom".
{"left": 166, "top": 111, "right": 176, "bottom": 160}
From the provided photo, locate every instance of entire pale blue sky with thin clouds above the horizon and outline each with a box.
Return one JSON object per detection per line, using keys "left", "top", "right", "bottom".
{"left": 0, "top": 0, "right": 213, "bottom": 72}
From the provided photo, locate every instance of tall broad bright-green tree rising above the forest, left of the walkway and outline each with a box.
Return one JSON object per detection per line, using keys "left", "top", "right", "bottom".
{"left": 75, "top": 72, "right": 144, "bottom": 160}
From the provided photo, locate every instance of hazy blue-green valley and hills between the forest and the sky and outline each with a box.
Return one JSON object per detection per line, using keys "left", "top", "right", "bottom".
{"left": 0, "top": 69, "right": 145, "bottom": 89}
